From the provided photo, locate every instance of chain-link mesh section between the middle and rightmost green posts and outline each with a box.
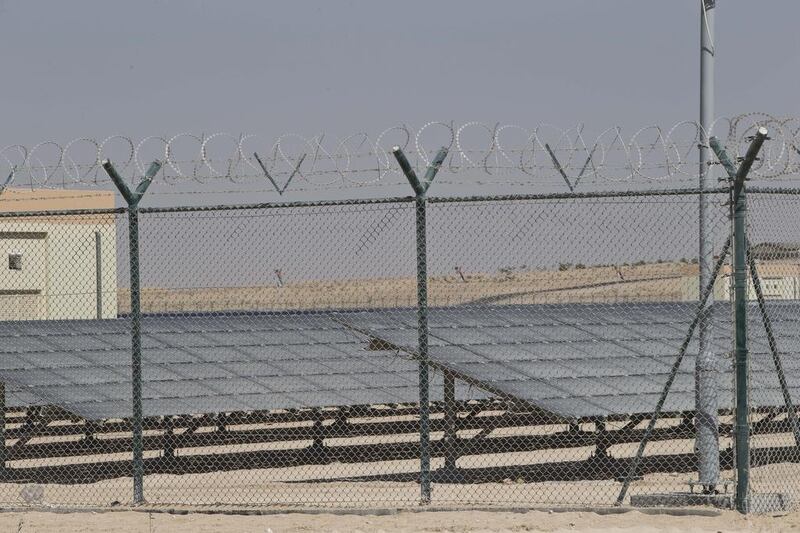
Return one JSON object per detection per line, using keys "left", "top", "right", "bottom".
{"left": 422, "top": 191, "right": 729, "bottom": 504}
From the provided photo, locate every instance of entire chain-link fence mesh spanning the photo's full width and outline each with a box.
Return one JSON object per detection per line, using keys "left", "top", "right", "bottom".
{"left": 0, "top": 184, "right": 800, "bottom": 508}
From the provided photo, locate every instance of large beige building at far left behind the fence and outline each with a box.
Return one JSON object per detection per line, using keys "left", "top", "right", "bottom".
{"left": 0, "top": 189, "right": 117, "bottom": 320}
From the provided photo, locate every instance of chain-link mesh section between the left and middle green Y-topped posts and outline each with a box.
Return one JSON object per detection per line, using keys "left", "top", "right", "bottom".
{"left": 141, "top": 203, "right": 434, "bottom": 506}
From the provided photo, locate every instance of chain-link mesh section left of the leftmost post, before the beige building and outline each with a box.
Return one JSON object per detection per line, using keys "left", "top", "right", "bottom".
{"left": 0, "top": 210, "right": 131, "bottom": 506}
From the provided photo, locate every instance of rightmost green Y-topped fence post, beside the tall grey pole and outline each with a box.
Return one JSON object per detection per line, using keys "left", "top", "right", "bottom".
{"left": 710, "top": 127, "right": 767, "bottom": 513}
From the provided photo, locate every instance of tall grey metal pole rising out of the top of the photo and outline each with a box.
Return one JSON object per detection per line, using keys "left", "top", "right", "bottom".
{"left": 695, "top": 0, "right": 719, "bottom": 493}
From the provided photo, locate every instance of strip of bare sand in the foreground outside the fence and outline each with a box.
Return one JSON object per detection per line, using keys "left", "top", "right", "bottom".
{"left": 0, "top": 511, "right": 800, "bottom": 533}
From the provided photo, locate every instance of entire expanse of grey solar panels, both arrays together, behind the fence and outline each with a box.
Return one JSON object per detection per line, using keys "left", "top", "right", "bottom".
{"left": 0, "top": 302, "right": 800, "bottom": 419}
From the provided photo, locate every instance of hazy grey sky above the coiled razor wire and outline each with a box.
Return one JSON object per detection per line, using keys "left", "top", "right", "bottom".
{"left": 0, "top": 0, "right": 800, "bottom": 146}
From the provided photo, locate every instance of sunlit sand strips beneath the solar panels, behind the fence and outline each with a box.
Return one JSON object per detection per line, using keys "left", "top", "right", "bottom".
{"left": 0, "top": 420, "right": 800, "bottom": 508}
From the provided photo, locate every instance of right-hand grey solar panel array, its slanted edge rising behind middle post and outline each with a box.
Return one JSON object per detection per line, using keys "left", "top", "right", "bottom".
{"left": 342, "top": 302, "right": 800, "bottom": 418}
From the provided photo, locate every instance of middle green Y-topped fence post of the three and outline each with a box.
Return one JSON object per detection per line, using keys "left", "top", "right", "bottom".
{"left": 392, "top": 146, "right": 447, "bottom": 504}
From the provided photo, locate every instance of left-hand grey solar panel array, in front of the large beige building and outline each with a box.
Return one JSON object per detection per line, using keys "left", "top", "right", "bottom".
{"left": 0, "top": 315, "right": 484, "bottom": 420}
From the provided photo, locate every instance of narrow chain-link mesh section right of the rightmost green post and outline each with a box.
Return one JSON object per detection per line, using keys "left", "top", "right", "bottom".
{"left": 747, "top": 193, "right": 800, "bottom": 510}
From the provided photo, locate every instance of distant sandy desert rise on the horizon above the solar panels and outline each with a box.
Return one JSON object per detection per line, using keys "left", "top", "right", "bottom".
{"left": 117, "top": 263, "right": 697, "bottom": 313}
